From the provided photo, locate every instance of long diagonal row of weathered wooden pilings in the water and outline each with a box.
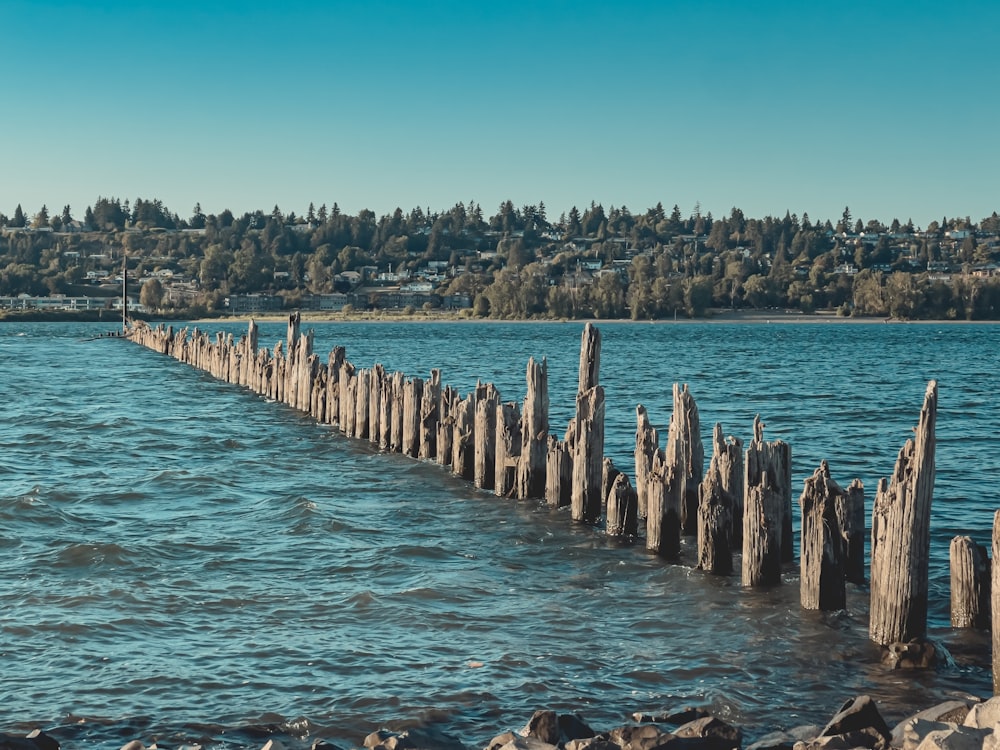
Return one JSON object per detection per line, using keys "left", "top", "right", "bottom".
{"left": 128, "top": 313, "right": 1000, "bottom": 692}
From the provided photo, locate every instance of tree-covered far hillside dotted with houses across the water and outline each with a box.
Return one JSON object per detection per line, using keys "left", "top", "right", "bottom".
{"left": 0, "top": 198, "right": 1000, "bottom": 320}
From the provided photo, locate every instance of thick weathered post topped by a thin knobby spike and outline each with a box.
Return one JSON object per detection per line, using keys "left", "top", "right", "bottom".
{"left": 742, "top": 415, "right": 792, "bottom": 586}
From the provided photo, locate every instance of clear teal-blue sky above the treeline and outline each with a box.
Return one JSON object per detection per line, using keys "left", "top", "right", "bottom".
{"left": 0, "top": 0, "right": 1000, "bottom": 226}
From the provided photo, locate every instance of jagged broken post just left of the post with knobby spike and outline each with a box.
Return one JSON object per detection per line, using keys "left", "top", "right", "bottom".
{"left": 698, "top": 422, "right": 743, "bottom": 575}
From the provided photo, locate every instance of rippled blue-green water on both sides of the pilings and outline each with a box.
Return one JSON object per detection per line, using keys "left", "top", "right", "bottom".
{"left": 0, "top": 323, "right": 1000, "bottom": 748}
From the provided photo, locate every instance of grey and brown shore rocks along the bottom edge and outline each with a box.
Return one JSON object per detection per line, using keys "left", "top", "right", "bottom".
{"left": 0, "top": 695, "right": 1000, "bottom": 750}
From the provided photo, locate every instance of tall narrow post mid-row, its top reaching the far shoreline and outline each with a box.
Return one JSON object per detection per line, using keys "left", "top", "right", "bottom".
{"left": 571, "top": 323, "right": 604, "bottom": 523}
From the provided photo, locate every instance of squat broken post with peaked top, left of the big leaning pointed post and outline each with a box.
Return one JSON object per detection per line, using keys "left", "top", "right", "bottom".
{"left": 799, "top": 461, "right": 847, "bottom": 610}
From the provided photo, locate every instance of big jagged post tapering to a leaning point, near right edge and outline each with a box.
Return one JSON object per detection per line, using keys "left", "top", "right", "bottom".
{"left": 869, "top": 380, "right": 938, "bottom": 646}
